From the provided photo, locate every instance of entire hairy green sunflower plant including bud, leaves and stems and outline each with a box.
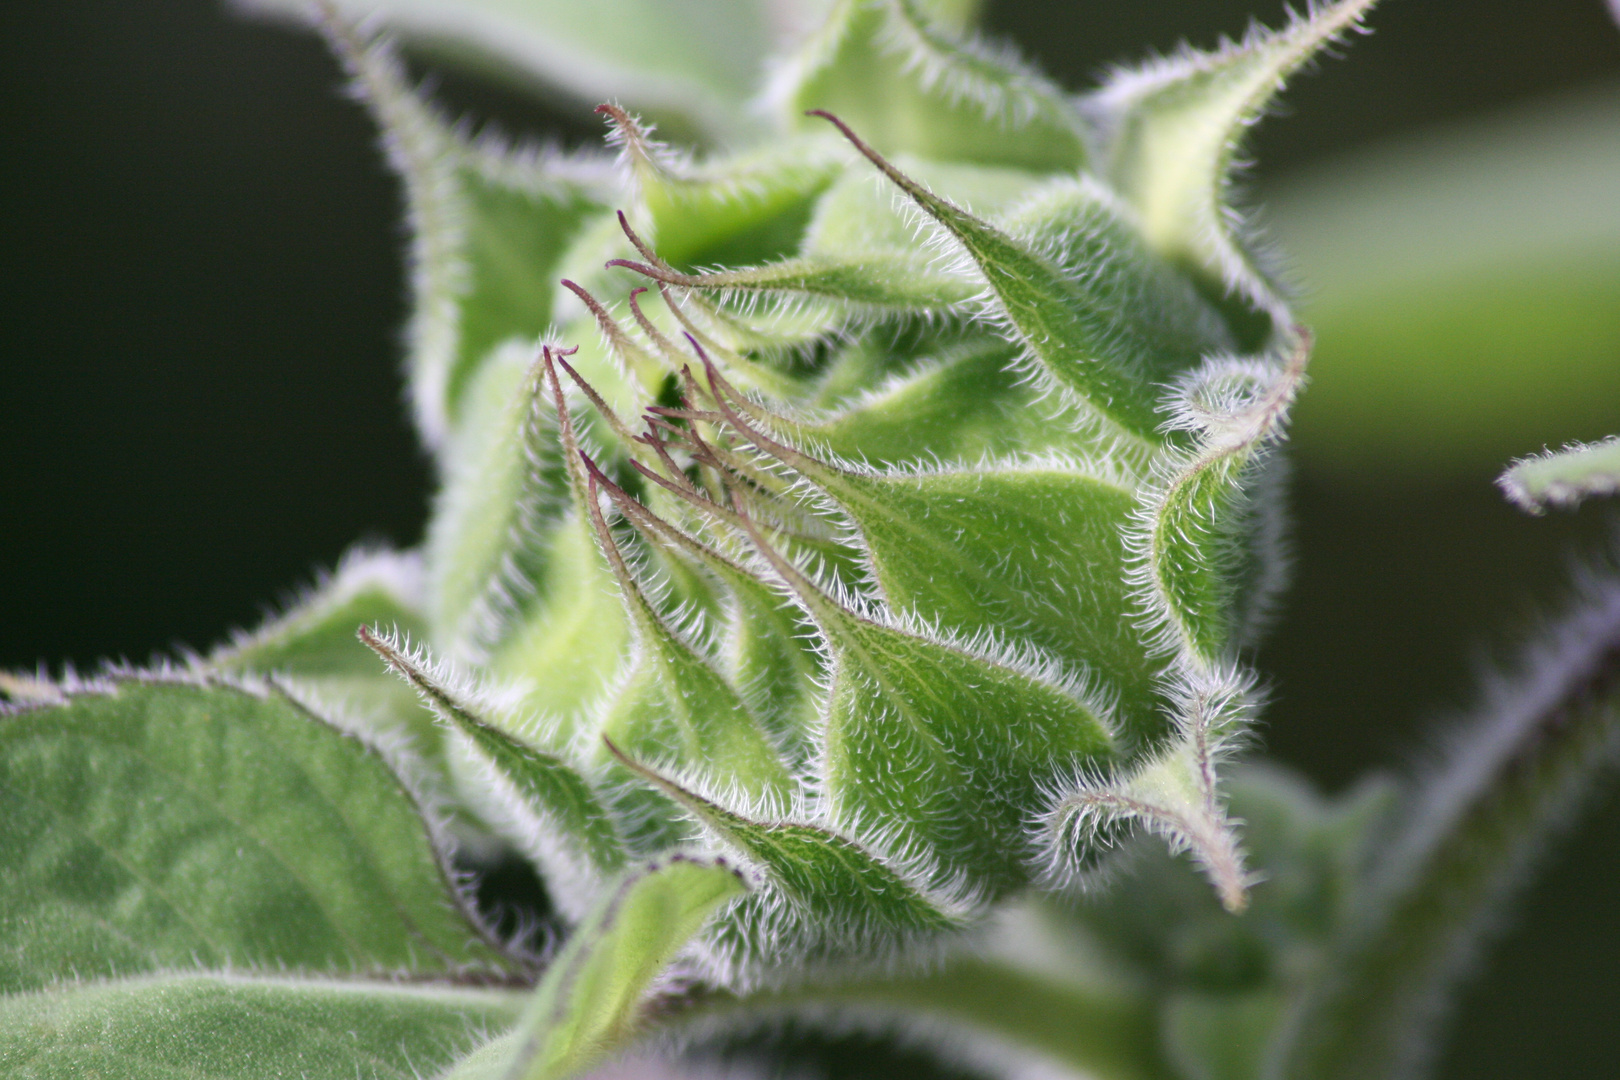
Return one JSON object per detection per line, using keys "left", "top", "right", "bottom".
{"left": 12, "top": 0, "right": 1620, "bottom": 1080}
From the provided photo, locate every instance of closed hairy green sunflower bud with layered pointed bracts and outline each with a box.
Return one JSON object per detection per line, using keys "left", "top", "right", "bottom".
{"left": 301, "top": 0, "right": 1369, "bottom": 984}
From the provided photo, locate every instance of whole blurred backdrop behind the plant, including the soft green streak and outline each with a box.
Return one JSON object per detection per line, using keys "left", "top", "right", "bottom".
{"left": 0, "top": 0, "right": 1620, "bottom": 1078}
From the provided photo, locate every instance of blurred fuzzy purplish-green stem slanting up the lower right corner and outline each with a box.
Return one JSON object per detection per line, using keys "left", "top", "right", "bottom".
{"left": 1270, "top": 580, "right": 1620, "bottom": 1080}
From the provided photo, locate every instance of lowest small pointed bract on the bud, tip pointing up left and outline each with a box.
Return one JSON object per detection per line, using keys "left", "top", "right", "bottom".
{"left": 609, "top": 743, "right": 967, "bottom": 984}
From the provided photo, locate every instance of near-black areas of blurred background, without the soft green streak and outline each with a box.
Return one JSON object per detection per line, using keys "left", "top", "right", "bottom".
{"left": 0, "top": 0, "right": 1620, "bottom": 1078}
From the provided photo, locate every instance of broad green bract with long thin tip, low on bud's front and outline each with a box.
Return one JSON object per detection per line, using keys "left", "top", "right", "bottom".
{"left": 709, "top": 501, "right": 1115, "bottom": 899}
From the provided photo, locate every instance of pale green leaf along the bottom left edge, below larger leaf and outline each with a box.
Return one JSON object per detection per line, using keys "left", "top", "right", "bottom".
{"left": 0, "top": 973, "right": 523, "bottom": 1080}
